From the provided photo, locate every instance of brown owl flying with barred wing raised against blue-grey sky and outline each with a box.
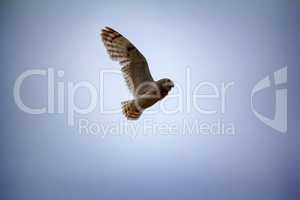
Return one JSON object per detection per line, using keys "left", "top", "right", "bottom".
{"left": 101, "top": 27, "right": 174, "bottom": 120}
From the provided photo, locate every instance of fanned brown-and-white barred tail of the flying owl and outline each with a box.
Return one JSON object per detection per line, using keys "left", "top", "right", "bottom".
{"left": 121, "top": 100, "right": 143, "bottom": 120}
